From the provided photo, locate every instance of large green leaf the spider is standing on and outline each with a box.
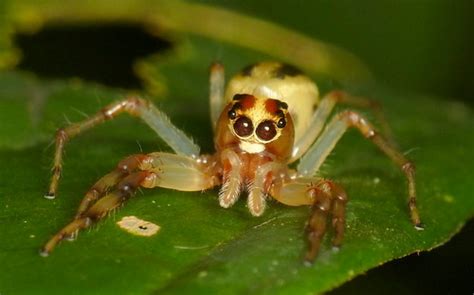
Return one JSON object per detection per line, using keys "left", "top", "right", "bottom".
{"left": 0, "top": 1, "right": 474, "bottom": 294}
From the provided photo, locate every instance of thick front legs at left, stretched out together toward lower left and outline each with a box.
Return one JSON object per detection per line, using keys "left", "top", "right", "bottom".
{"left": 40, "top": 153, "right": 220, "bottom": 256}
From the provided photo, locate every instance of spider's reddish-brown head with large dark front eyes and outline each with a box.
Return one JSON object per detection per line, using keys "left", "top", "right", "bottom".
{"left": 216, "top": 94, "right": 294, "bottom": 158}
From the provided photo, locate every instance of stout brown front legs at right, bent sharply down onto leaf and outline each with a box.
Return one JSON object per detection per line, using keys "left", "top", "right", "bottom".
{"left": 271, "top": 178, "right": 347, "bottom": 264}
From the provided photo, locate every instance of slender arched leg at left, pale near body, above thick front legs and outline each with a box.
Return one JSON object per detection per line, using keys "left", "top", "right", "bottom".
{"left": 45, "top": 97, "right": 199, "bottom": 199}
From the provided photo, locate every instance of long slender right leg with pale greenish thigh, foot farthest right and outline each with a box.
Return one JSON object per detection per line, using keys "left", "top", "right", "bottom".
{"left": 297, "top": 111, "right": 422, "bottom": 229}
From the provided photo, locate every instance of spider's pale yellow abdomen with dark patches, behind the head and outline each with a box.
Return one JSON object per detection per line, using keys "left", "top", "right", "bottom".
{"left": 225, "top": 62, "right": 319, "bottom": 140}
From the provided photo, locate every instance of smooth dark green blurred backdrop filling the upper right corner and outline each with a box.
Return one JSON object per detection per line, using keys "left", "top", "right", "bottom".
{"left": 211, "top": 0, "right": 474, "bottom": 102}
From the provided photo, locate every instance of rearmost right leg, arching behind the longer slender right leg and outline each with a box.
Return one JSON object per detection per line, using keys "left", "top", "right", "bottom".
{"left": 290, "top": 91, "right": 394, "bottom": 162}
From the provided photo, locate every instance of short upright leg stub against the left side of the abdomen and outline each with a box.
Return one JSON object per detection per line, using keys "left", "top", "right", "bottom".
{"left": 209, "top": 62, "right": 225, "bottom": 129}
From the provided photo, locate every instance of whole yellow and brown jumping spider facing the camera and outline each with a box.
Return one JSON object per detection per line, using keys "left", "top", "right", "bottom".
{"left": 41, "top": 62, "right": 422, "bottom": 262}
